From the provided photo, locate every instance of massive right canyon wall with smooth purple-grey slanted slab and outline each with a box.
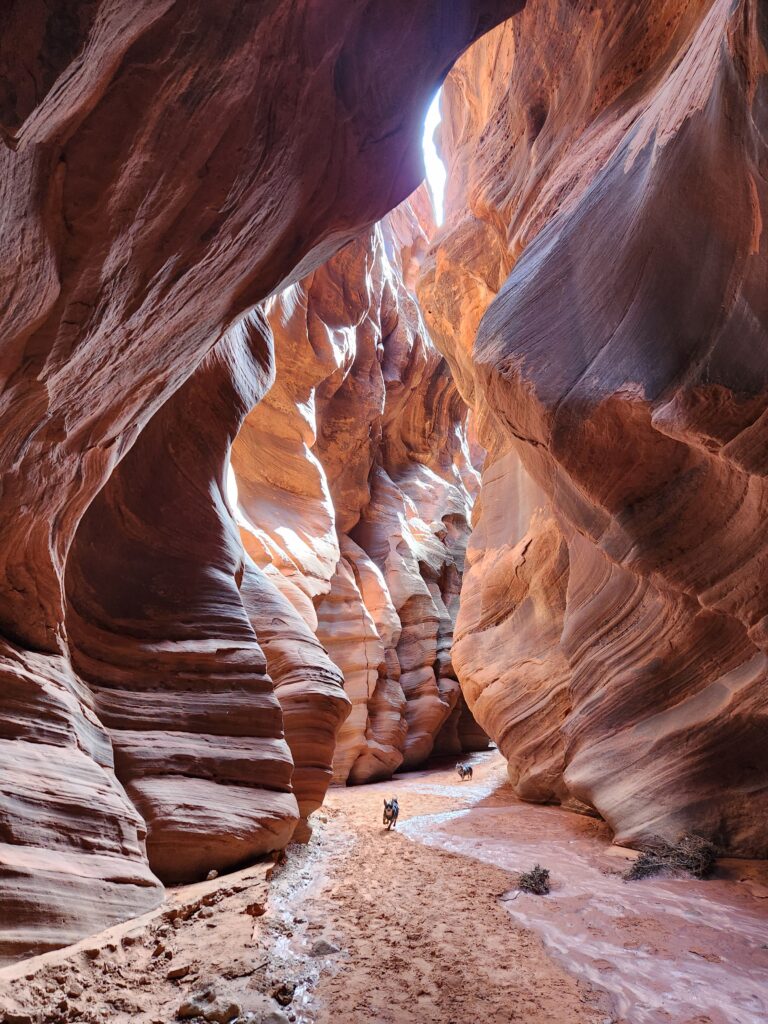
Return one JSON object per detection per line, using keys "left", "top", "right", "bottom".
{"left": 419, "top": 0, "right": 768, "bottom": 855}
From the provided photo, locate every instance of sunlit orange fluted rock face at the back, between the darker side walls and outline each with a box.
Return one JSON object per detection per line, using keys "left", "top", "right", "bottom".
{"left": 231, "top": 189, "right": 487, "bottom": 782}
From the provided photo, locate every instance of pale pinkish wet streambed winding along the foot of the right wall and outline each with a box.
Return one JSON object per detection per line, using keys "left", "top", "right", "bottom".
{"left": 376, "top": 754, "right": 768, "bottom": 1024}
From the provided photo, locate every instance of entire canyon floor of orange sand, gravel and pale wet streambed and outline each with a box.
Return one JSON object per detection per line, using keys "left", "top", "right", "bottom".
{"left": 0, "top": 751, "right": 768, "bottom": 1024}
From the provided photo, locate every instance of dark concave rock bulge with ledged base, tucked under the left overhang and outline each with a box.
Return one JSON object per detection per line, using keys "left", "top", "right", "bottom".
{"left": 67, "top": 312, "right": 305, "bottom": 883}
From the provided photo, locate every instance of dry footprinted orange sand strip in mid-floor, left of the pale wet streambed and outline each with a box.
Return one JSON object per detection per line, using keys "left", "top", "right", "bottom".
{"left": 301, "top": 767, "right": 612, "bottom": 1024}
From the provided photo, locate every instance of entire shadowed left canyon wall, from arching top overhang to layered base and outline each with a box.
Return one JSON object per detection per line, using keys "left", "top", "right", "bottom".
{"left": 0, "top": 0, "right": 521, "bottom": 957}
